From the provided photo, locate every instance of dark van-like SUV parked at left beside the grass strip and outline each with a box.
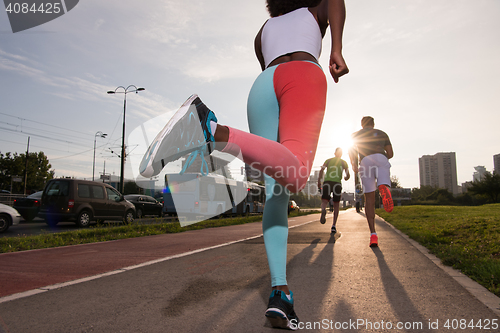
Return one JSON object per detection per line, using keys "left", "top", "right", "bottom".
{"left": 38, "top": 179, "right": 135, "bottom": 227}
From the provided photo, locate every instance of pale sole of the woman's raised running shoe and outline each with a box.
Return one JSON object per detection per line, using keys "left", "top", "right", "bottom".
{"left": 139, "top": 94, "right": 198, "bottom": 178}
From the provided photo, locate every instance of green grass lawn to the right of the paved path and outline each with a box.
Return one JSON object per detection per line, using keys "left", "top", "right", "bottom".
{"left": 376, "top": 204, "right": 500, "bottom": 296}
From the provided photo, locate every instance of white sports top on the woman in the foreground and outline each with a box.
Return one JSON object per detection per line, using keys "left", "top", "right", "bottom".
{"left": 261, "top": 7, "right": 322, "bottom": 68}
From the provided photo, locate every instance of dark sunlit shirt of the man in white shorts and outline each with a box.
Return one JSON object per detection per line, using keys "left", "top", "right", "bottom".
{"left": 352, "top": 128, "right": 391, "bottom": 162}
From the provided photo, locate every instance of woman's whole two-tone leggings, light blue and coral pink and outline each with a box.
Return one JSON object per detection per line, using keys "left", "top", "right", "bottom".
{"left": 223, "top": 61, "right": 326, "bottom": 286}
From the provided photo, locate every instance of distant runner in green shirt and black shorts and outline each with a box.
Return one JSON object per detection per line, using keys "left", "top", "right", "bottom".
{"left": 318, "top": 147, "right": 351, "bottom": 234}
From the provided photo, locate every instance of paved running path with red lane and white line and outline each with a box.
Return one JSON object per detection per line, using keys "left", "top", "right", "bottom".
{"left": 0, "top": 210, "right": 500, "bottom": 333}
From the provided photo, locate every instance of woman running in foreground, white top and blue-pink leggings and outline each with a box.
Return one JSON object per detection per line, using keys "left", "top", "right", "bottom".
{"left": 140, "top": 0, "right": 349, "bottom": 329}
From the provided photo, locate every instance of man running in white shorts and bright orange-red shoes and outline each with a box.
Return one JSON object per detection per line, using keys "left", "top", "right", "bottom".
{"left": 349, "top": 117, "right": 394, "bottom": 247}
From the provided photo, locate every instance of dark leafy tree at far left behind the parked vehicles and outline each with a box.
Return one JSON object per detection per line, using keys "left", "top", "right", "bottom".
{"left": 0, "top": 152, "right": 54, "bottom": 193}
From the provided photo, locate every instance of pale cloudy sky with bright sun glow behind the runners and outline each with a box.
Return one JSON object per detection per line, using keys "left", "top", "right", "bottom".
{"left": 0, "top": 0, "right": 500, "bottom": 191}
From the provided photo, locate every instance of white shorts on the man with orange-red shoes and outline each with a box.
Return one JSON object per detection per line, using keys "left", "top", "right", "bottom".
{"left": 359, "top": 154, "right": 391, "bottom": 193}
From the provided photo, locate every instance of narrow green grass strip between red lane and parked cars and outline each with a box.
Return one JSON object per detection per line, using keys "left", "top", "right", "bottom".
{"left": 0, "top": 212, "right": 316, "bottom": 253}
